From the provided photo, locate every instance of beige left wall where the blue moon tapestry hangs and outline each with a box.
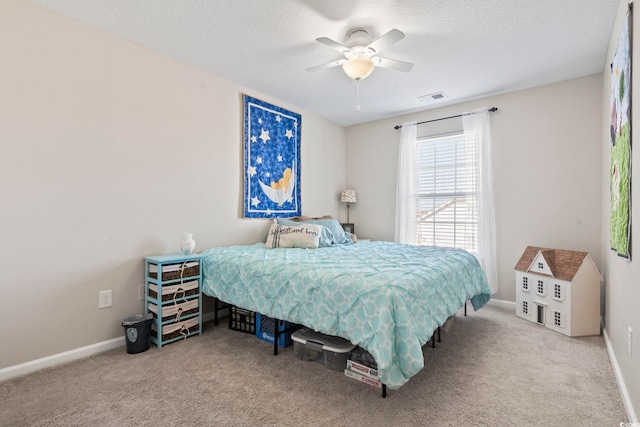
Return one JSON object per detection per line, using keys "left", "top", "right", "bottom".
{"left": 0, "top": 0, "right": 345, "bottom": 369}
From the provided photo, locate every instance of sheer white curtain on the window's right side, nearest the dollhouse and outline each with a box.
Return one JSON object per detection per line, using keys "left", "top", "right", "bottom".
{"left": 462, "top": 108, "right": 498, "bottom": 293}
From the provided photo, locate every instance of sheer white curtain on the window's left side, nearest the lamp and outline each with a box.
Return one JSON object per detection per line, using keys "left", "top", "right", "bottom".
{"left": 394, "top": 122, "right": 418, "bottom": 245}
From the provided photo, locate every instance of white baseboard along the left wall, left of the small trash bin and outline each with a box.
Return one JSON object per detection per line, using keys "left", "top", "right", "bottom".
{"left": 0, "top": 336, "right": 126, "bottom": 382}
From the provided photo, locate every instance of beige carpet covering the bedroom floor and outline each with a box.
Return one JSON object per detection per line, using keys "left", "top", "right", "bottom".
{"left": 0, "top": 306, "right": 626, "bottom": 426}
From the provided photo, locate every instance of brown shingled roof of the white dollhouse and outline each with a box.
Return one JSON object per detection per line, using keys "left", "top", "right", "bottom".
{"left": 515, "top": 246, "right": 589, "bottom": 282}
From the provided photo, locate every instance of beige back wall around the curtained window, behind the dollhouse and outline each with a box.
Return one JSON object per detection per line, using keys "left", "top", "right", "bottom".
{"left": 347, "top": 74, "right": 602, "bottom": 301}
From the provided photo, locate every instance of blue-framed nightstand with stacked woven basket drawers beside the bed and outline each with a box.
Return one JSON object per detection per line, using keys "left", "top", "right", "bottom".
{"left": 144, "top": 254, "right": 202, "bottom": 347}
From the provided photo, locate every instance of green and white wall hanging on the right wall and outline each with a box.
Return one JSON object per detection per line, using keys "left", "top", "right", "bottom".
{"left": 609, "top": 5, "right": 632, "bottom": 260}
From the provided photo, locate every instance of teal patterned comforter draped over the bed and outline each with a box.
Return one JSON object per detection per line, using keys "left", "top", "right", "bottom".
{"left": 202, "top": 241, "right": 491, "bottom": 389}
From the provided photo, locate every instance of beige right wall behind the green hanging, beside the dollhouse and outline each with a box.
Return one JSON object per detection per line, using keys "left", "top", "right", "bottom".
{"left": 601, "top": 1, "right": 640, "bottom": 421}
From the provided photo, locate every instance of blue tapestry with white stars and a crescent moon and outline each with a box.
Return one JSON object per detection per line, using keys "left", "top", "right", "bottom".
{"left": 244, "top": 95, "right": 302, "bottom": 218}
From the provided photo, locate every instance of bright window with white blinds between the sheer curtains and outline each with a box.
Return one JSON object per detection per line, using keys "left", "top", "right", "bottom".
{"left": 416, "top": 133, "right": 478, "bottom": 252}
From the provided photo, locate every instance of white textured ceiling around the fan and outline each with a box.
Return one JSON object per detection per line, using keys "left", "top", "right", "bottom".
{"left": 31, "top": 0, "right": 619, "bottom": 126}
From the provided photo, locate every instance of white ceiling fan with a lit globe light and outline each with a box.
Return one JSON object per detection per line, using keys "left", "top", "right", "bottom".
{"left": 307, "top": 29, "right": 413, "bottom": 81}
